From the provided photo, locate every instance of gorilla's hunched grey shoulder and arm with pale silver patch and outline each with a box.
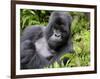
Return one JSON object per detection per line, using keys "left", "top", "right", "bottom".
{"left": 20, "top": 26, "right": 52, "bottom": 69}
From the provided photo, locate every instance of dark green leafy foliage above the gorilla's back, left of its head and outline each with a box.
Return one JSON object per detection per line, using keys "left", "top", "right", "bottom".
{"left": 20, "top": 9, "right": 50, "bottom": 30}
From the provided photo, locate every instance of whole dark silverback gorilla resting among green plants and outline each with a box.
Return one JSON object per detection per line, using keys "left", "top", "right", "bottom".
{"left": 20, "top": 11, "right": 73, "bottom": 69}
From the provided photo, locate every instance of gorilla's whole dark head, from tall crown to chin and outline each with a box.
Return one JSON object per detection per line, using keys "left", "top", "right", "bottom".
{"left": 47, "top": 12, "right": 72, "bottom": 50}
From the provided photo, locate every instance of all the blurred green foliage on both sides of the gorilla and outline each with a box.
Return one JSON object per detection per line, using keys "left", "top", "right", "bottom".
{"left": 20, "top": 9, "right": 90, "bottom": 68}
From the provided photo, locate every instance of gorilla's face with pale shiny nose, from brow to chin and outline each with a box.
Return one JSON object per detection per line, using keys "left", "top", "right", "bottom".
{"left": 48, "top": 25, "right": 67, "bottom": 49}
